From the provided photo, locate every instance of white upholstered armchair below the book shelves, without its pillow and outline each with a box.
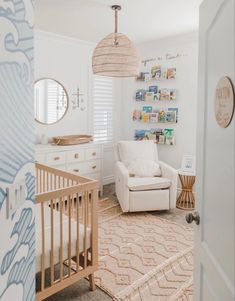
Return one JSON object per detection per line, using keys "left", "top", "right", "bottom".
{"left": 115, "top": 141, "right": 178, "bottom": 212}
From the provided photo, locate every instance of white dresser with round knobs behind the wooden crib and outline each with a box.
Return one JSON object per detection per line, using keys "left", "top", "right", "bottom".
{"left": 36, "top": 142, "right": 103, "bottom": 194}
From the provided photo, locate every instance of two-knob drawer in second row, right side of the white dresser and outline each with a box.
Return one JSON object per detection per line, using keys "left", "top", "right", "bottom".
{"left": 67, "top": 160, "right": 101, "bottom": 175}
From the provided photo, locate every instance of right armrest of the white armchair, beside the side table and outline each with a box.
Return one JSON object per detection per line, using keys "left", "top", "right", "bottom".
{"left": 159, "top": 161, "right": 178, "bottom": 208}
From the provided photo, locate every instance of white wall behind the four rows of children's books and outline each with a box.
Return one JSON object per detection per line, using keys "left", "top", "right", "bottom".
{"left": 121, "top": 33, "right": 198, "bottom": 168}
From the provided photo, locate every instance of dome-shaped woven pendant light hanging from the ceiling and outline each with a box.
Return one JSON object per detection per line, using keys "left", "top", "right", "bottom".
{"left": 92, "top": 5, "right": 140, "bottom": 77}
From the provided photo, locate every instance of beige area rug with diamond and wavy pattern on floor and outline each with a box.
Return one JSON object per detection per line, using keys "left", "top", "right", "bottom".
{"left": 95, "top": 199, "right": 193, "bottom": 301}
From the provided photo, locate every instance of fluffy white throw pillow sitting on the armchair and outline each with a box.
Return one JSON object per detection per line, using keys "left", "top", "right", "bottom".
{"left": 128, "top": 159, "right": 162, "bottom": 177}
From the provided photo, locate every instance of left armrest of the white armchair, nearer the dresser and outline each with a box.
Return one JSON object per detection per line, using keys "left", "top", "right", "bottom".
{"left": 115, "top": 161, "right": 129, "bottom": 212}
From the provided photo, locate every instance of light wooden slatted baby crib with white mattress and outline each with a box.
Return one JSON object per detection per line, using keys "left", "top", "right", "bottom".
{"left": 35, "top": 163, "right": 98, "bottom": 301}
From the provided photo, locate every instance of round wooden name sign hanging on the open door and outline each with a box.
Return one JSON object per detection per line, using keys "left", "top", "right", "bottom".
{"left": 215, "top": 76, "right": 234, "bottom": 128}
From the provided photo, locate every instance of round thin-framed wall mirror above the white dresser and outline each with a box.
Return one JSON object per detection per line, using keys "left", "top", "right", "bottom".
{"left": 34, "top": 78, "right": 68, "bottom": 124}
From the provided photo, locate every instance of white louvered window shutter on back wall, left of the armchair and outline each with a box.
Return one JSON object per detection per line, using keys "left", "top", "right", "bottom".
{"left": 93, "top": 75, "right": 114, "bottom": 142}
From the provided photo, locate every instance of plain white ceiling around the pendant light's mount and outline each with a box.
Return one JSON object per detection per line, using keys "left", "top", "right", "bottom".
{"left": 35, "top": 0, "right": 202, "bottom": 43}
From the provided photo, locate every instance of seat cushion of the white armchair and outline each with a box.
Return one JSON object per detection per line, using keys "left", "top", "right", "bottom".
{"left": 128, "top": 177, "right": 171, "bottom": 190}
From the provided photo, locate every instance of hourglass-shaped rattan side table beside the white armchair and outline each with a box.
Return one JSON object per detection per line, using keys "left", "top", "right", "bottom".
{"left": 176, "top": 172, "right": 196, "bottom": 210}
